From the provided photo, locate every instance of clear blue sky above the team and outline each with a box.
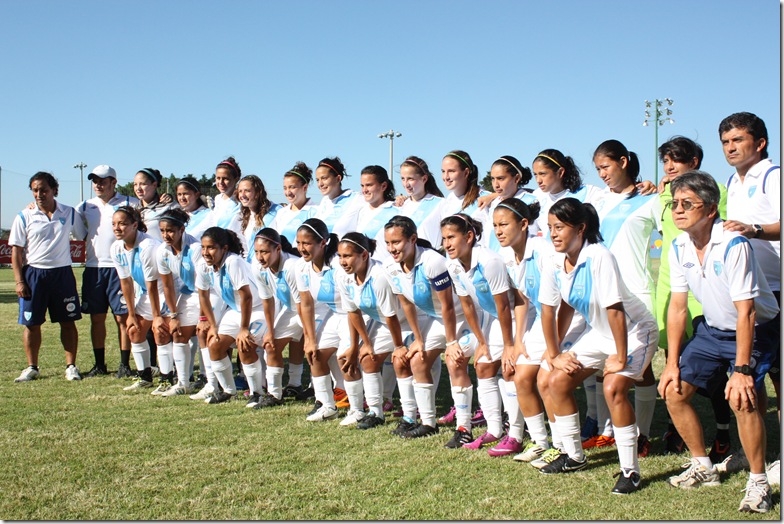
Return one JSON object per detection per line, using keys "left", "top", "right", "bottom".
{"left": 0, "top": 0, "right": 781, "bottom": 228}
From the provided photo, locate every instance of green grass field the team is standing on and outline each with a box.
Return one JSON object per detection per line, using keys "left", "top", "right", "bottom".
{"left": 0, "top": 269, "right": 781, "bottom": 520}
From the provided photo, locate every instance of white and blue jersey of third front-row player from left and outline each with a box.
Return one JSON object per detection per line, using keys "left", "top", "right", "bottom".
{"left": 196, "top": 253, "right": 262, "bottom": 313}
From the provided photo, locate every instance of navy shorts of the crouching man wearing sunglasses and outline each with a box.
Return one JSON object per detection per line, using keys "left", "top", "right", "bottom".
{"left": 679, "top": 316, "right": 781, "bottom": 395}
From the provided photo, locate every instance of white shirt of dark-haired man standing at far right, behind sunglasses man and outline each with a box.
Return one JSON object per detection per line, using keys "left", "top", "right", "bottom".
{"left": 727, "top": 158, "right": 781, "bottom": 291}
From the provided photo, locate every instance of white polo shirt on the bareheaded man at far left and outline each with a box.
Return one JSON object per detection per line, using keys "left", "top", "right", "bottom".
{"left": 8, "top": 200, "right": 87, "bottom": 269}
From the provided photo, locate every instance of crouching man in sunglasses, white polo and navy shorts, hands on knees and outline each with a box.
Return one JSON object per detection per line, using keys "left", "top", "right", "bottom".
{"left": 659, "top": 171, "right": 780, "bottom": 513}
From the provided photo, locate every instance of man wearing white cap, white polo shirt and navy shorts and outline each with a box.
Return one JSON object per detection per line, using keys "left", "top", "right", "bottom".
{"left": 76, "top": 165, "right": 139, "bottom": 378}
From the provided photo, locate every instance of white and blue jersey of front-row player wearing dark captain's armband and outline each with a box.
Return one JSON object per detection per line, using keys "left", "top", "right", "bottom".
{"left": 384, "top": 246, "right": 463, "bottom": 321}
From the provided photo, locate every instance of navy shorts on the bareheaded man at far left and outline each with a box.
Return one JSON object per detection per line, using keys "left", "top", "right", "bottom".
{"left": 19, "top": 266, "right": 82, "bottom": 326}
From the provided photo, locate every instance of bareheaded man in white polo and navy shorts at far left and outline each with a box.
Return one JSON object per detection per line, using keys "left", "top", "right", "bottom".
{"left": 8, "top": 171, "right": 85, "bottom": 382}
